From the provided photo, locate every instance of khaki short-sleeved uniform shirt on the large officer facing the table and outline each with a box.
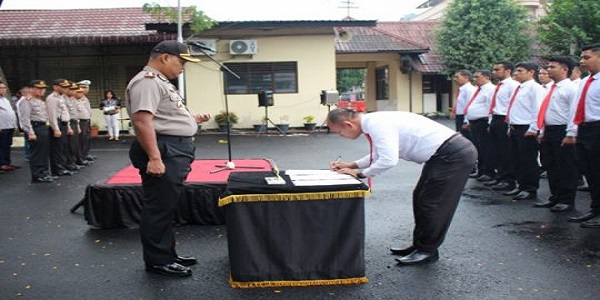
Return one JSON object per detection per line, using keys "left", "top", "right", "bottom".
{"left": 125, "top": 66, "right": 198, "bottom": 137}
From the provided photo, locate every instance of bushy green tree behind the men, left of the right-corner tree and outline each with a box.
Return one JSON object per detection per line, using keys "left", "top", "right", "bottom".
{"left": 435, "top": 0, "right": 532, "bottom": 74}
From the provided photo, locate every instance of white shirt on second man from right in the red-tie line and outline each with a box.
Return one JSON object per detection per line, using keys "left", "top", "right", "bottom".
{"left": 544, "top": 78, "right": 577, "bottom": 132}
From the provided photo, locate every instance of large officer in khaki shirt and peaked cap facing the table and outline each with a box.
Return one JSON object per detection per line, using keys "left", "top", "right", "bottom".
{"left": 126, "top": 40, "right": 210, "bottom": 277}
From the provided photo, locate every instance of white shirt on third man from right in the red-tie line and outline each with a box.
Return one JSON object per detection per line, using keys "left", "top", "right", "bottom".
{"left": 508, "top": 79, "right": 547, "bottom": 133}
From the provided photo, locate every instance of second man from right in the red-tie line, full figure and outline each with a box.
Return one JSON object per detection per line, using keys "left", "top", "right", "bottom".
{"left": 534, "top": 56, "right": 579, "bottom": 212}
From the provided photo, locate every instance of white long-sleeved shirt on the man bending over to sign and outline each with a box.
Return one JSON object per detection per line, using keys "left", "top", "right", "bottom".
{"left": 354, "top": 111, "right": 456, "bottom": 177}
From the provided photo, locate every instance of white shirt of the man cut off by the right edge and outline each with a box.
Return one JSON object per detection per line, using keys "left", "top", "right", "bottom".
{"left": 567, "top": 72, "right": 600, "bottom": 136}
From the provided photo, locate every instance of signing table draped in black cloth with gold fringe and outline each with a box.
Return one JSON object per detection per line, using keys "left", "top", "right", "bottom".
{"left": 219, "top": 172, "right": 369, "bottom": 288}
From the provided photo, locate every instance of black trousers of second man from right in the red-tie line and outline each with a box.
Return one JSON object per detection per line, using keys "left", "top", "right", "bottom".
{"left": 540, "top": 125, "right": 579, "bottom": 204}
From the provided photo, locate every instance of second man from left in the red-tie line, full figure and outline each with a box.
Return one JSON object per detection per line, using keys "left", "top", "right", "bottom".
{"left": 463, "top": 70, "right": 496, "bottom": 182}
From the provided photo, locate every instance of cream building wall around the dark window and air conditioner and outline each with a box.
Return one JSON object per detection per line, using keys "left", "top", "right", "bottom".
{"left": 185, "top": 36, "right": 336, "bottom": 128}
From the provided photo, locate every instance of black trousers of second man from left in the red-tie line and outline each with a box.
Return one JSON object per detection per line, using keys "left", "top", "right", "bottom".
{"left": 469, "top": 117, "right": 496, "bottom": 177}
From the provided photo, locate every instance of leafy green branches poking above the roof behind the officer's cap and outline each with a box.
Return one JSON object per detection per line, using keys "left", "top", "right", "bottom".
{"left": 142, "top": 3, "right": 217, "bottom": 34}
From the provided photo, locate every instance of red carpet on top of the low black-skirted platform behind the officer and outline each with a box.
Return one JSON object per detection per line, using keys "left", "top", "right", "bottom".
{"left": 106, "top": 158, "right": 272, "bottom": 184}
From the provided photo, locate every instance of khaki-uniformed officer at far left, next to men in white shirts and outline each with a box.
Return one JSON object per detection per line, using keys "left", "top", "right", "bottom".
{"left": 17, "top": 79, "right": 55, "bottom": 183}
